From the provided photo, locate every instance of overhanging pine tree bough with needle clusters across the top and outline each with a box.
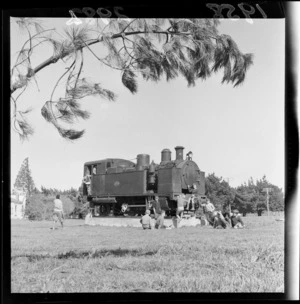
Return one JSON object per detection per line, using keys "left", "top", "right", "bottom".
{"left": 11, "top": 18, "right": 253, "bottom": 140}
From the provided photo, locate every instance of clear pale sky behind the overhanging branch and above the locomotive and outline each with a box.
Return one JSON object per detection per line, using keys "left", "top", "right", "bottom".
{"left": 11, "top": 18, "right": 285, "bottom": 189}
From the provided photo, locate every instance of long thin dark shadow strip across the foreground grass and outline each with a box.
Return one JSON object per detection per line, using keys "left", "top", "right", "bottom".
{"left": 12, "top": 248, "right": 158, "bottom": 262}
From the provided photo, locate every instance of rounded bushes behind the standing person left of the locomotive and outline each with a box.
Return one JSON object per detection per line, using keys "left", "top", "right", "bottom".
{"left": 25, "top": 193, "right": 74, "bottom": 221}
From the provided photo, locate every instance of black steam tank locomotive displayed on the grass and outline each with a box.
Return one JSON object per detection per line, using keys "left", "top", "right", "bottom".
{"left": 82, "top": 146, "right": 206, "bottom": 216}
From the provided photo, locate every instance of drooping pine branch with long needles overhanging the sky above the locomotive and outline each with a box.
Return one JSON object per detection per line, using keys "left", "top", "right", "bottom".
{"left": 11, "top": 19, "right": 253, "bottom": 139}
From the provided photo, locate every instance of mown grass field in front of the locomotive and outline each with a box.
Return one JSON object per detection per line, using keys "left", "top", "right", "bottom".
{"left": 11, "top": 216, "right": 284, "bottom": 293}
